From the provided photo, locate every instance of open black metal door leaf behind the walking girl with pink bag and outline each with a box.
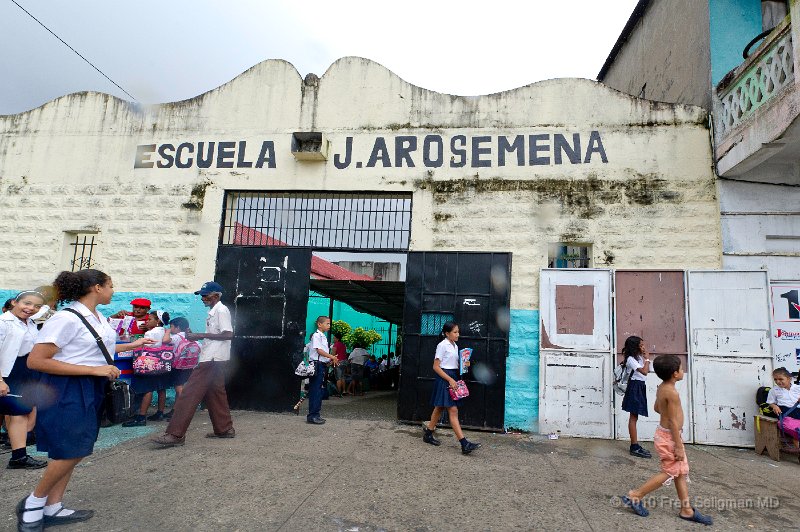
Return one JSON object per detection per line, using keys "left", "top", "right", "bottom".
{"left": 397, "top": 251, "right": 511, "bottom": 430}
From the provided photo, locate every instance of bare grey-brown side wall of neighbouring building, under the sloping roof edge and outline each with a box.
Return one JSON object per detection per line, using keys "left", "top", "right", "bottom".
{"left": 601, "top": 0, "right": 711, "bottom": 109}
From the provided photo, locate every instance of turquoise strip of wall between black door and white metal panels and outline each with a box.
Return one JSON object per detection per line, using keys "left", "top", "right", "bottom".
{"left": 505, "top": 309, "right": 539, "bottom": 432}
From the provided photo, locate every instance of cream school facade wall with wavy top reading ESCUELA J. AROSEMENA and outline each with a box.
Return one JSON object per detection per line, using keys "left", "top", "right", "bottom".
{"left": 0, "top": 57, "right": 721, "bottom": 430}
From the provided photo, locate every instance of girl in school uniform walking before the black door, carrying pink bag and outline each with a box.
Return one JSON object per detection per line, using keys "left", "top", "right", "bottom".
{"left": 422, "top": 321, "right": 481, "bottom": 454}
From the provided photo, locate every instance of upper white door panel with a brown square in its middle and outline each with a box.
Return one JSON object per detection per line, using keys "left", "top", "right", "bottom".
{"left": 540, "top": 269, "right": 611, "bottom": 352}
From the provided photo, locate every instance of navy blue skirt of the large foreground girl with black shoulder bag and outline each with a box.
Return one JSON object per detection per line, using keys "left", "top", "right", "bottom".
{"left": 36, "top": 373, "right": 108, "bottom": 460}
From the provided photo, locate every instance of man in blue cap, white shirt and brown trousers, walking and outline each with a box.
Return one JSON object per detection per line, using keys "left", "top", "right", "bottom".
{"left": 151, "top": 281, "right": 236, "bottom": 447}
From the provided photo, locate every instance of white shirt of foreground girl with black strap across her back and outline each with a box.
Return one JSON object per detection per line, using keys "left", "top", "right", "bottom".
{"left": 36, "top": 301, "right": 117, "bottom": 366}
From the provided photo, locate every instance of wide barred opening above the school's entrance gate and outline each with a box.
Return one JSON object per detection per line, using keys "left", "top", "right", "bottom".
{"left": 220, "top": 191, "right": 411, "bottom": 251}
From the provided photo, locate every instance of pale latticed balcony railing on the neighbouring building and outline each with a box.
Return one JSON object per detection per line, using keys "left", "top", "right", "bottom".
{"left": 716, "top": 24, "right": 794, "bottom": 139}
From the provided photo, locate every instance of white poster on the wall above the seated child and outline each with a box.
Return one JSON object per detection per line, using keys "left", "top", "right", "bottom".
{"left": 770, "top": 282, "right": 800, "bottom": 371}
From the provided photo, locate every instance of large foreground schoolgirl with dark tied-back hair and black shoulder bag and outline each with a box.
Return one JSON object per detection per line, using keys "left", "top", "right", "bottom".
{"left": 17, "top": 270, "right": 151, "bottom": 531}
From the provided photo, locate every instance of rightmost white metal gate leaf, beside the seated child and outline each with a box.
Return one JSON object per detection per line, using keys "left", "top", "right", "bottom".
{"left": 688, "top": 271, "right": 772, "bottom": 447}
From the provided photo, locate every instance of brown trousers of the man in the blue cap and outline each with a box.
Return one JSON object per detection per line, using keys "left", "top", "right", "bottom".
{"left": 166, "top": 362, "right": 233, "bottom": 438}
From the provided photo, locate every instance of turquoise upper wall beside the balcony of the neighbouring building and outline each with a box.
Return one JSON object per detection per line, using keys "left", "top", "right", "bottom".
{"left": 709, "top": 0, "right": 761, "bottom": 86}
